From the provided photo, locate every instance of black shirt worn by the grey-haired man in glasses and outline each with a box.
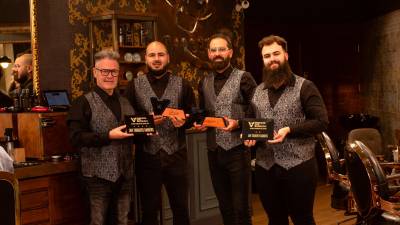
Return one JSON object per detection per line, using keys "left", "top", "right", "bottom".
{"left": 67, "top": 86, "right": 123, "bottom": 147}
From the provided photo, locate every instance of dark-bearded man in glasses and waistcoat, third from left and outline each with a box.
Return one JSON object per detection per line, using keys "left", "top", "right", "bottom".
{"left": 195, "top": 34, "right": 257, "bottom": 225}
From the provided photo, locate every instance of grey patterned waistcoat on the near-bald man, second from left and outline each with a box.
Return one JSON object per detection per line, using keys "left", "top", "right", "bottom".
{"left": 134, "top": 76, "right": 182, "bottom": 155}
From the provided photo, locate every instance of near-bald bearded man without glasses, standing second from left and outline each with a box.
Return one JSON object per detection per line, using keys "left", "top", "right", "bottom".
{"left": 126, "top": 41, "right": 195, "bottom": 225}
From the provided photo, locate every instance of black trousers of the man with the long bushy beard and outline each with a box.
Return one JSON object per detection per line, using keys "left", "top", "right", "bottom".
{"left": 256, "top": 158, "right": 318, "bottom": 225}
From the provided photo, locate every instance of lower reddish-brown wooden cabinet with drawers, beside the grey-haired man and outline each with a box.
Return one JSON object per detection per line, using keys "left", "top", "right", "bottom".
{"left": 17, "top": 167, "right": 89, "bottom": 225}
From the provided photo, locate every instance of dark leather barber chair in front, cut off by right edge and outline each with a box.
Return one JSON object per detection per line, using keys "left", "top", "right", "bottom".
{"left": 345, "top": 141, "right": 400, "bottom": 225}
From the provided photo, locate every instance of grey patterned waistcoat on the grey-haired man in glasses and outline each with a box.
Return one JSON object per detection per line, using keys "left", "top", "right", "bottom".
{"left": 81, "top": 92, "right": 134, "bottom": 182}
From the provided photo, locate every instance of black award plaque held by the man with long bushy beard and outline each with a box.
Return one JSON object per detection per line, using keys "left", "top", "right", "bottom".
{"left": 241, "top": 119, "right": 274, "bottom": 140}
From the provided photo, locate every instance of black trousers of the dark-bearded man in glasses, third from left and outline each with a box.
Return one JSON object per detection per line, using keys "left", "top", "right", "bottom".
{"left": 208, "top": 145, "right": 251, "bottom": 225}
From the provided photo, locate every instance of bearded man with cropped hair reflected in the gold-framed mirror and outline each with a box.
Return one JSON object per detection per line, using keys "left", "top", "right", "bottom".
{"left": 8, "top": 54, "right": 33, "bottom": 95}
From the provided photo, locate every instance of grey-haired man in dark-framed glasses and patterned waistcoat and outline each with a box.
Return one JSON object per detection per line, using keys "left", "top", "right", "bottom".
{"left": 67, "top": 50, "right": 135, "bottom": 225}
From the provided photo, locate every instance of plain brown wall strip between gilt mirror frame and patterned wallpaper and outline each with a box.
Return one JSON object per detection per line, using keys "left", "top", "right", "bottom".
{"left": 37, "top": 0, "right": 72, "bottom": 91}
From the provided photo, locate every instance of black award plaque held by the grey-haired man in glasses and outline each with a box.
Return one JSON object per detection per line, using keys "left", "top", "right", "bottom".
{"left": 125, "top": 115, "right": 156, "bottom": 134}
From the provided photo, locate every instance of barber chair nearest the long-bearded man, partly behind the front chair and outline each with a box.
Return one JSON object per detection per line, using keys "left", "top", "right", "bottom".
{"left": 317, "top": 132, "right": 356, "bottom": 225}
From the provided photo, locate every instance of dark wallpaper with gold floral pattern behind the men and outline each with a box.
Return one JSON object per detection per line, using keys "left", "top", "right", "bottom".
{"left": 68, "top": 0, "right": 244, "bottom": 98}
